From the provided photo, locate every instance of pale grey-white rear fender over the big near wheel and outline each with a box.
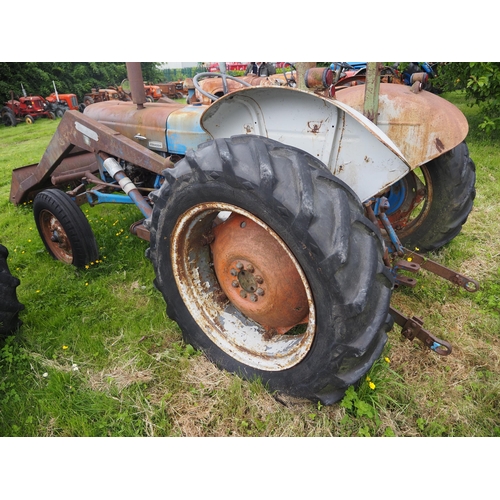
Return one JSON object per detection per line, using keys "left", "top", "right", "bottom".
{"left": 201, "top": 87, "right": 411, "bottom": 201}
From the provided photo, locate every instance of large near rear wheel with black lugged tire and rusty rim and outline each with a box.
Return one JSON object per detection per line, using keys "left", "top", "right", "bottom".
{"left": 149, "top": 136, "right": 394, "bottom": 404}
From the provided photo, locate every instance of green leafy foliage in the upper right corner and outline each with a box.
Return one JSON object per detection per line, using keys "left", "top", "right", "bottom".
{"left": 436, "top": 62, "right": 500, "bottom": 132}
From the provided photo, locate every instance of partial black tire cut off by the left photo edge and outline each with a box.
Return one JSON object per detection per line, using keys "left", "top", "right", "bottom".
{"left": 0, "top": 245, "right": 24, "bottom": 335}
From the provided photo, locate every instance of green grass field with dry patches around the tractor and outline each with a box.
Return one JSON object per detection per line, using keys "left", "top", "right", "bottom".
{"left": 0, "top": 94, "right": 500, "bottom": 437}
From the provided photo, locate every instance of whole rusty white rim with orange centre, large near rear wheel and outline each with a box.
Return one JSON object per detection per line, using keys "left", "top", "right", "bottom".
{"left": 170, "top": 202, "right": 316, "bottom": 371}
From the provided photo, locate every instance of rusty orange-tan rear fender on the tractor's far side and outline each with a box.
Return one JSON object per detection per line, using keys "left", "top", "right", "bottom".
{"left": 336, "top": 83, "right": 469, "bottom": 168}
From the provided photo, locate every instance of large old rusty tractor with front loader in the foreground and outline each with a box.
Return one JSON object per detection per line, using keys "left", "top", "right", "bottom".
{"left": 6, "top": 63, "right": 479, "bottom": 404}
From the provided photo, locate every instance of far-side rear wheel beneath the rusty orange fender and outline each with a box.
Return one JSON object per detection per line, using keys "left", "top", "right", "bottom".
{"left": 388, "top": 142, "right": 476, "bottom": 252}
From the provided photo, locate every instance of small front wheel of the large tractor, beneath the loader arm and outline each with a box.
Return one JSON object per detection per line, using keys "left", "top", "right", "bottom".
{"left": 33, "top": 189, "right": 99, "bottom": 267}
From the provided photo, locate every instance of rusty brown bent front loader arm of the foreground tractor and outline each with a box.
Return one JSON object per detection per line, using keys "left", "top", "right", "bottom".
{"left": 10, "top": 111, "right": 171, "bottom": 205}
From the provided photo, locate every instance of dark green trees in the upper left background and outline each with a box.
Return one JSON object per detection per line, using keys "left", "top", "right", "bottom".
{"left": 0, "top": 62, "right": 163, "bottom": 103}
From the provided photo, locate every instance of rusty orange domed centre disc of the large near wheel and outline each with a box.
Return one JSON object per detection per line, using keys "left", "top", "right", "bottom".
{"left": 211, "top": 213, "right": 309, "bottom": 333}
